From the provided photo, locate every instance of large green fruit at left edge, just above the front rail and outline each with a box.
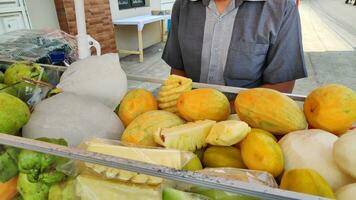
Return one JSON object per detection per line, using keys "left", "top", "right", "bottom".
{"left": 0, "top": 93, "right": 30, "bottom": 135}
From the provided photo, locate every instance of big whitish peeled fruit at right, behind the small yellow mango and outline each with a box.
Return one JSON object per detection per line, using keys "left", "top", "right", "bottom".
{"left": 279, "top": 129, "right": 354, "bottom": 191}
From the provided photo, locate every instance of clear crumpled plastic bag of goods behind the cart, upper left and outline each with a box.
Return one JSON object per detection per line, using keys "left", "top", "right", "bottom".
{"left": 0, "top": 30, "right": 78, "bottom": 64}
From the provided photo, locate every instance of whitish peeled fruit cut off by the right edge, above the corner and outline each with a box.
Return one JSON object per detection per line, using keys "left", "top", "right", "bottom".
{"left": 334, "top": 131, "right": 356, "bottom": 178}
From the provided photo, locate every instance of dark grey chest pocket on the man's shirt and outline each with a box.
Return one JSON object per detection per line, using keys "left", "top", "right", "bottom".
{"left": 225, "top": 40, "right": 269, "bottom": 81}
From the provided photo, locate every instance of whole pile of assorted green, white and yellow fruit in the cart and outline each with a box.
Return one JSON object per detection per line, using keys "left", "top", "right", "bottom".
{"left": 0, "top": 56, "right": 356, "bottom": 200}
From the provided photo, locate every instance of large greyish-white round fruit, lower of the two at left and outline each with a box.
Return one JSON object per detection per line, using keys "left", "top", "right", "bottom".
{"left": 22, "top": 92, "right": 124, "bottom": 146}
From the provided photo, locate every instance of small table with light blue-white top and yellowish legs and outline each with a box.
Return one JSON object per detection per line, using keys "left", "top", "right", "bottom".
{"left": 113, "top": 15, "right": 170, "bottom": 62}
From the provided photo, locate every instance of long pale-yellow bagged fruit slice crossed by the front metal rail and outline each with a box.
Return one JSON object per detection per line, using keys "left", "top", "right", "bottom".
{"left": 84, "top": 139, "right": 196, "bottom": 185}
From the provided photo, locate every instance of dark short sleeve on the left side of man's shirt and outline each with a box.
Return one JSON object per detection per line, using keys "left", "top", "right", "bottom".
{"left": 162, "top": 0, "right": 184, "bottom": 70}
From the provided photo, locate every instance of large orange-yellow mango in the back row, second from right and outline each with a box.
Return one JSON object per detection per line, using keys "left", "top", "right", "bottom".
{"left": 235, "top": 88, "right": 308, "bottom": 135}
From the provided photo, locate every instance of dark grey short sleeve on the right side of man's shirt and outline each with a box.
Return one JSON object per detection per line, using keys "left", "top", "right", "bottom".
{"left": 263, "top": 0, "right": 307, "bottom": 84}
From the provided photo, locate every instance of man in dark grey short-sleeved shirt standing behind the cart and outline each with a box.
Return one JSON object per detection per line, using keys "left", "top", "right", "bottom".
{"left": 162, "top": 0, "right": 306, "bottom": 93}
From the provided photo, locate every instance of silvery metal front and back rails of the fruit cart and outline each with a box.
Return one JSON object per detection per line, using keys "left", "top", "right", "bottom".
{"left": 0, "top": 60, "right": 350, "bottom": 200}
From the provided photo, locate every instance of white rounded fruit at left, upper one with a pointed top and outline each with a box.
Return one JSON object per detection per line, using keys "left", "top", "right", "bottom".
{"left": 57, "top": 54, "right": 127, "bottom": 110}
